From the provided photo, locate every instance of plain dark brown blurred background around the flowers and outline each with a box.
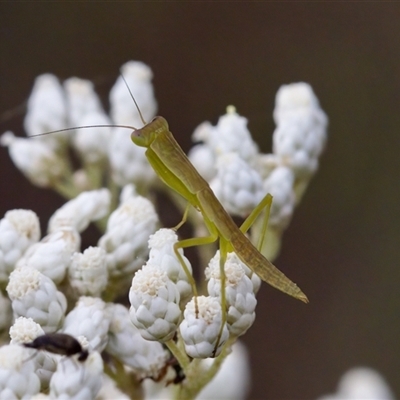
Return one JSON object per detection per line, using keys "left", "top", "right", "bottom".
{"left": 0, "top": 2, "right": 400, "bottom": 399}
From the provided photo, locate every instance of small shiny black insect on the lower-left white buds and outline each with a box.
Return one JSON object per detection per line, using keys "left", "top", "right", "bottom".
{"left": 23, "top": 333, "right": 89, "bottom": 362}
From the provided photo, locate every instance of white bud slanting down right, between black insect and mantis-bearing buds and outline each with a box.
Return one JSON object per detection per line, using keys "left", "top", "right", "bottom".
{"left": 106, "top": 304, "right": 169, "bottom": 379}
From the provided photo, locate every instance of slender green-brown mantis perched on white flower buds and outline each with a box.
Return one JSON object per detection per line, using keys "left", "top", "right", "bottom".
{"left": 131, "top": 117, "right": 308, "bottom": 303}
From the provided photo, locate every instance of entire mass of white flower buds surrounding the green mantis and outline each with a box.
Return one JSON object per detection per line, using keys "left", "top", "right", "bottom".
{"left": 0, "top": 61, "right": 326, "bottom": 400}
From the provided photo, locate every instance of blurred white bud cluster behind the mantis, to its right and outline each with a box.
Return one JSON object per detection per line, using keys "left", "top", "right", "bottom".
{"left": 189, "top": 83, "right": 328, "bottom": 259}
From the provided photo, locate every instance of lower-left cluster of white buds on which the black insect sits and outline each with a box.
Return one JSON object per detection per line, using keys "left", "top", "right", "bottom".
{"left": 0, "top": 185, "right": 161, "bottom": 398}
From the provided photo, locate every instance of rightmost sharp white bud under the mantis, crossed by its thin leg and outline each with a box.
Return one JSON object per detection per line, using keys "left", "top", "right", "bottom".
{"left": 205, "top": 251, "right": 257, "bottom": 336}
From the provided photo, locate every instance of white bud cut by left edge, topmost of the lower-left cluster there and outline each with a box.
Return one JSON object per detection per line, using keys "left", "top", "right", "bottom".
{"left": 0, "top": 210, "right": 40, "bottom": 282}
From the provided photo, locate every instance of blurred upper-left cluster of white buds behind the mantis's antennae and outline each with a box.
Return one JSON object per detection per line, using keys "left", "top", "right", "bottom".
{"left": 1, "top": 61, "right": 157, "bottom": 197}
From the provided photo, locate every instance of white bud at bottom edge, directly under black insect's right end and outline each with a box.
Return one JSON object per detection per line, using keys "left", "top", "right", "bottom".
{"left": 50, "top": 352, "right": 103, "bottom": 399}
